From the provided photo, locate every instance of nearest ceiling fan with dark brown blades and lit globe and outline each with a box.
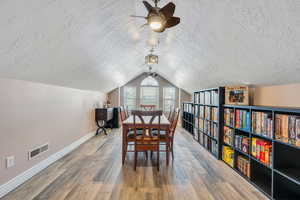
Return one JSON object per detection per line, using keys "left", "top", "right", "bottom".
{"left": 131, "top": 0, "right": 180, "bottom": 33}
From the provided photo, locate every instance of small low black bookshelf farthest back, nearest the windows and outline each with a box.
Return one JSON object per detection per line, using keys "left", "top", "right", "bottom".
{"left": 182, "top": 102, "right": 194, "bottom": 135}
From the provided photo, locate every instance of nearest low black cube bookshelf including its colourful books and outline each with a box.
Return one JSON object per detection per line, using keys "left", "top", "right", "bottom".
{"left": 220, "top": 105, "right": 300, "bottom": 200}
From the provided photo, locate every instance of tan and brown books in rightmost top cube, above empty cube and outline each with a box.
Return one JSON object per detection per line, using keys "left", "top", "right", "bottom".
{"left": 275, "top": 114, "right": 300, "bottom": 146}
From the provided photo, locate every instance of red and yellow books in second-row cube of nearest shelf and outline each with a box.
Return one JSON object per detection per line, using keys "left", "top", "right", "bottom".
{"left": 251, "top": 138, "right": 272, "bottom": 166}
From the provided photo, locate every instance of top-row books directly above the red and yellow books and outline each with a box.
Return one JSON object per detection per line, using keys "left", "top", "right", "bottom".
{"left": 252, "top": 111, "right": 273, "bottom": 138}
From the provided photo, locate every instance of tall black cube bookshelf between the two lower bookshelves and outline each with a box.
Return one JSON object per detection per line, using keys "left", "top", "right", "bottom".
{"left": 193, "top": 87, "right": 225, "bottom": 159}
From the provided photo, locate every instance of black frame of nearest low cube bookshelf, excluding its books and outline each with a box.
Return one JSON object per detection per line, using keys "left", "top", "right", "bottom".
{"left": 220, "top": 105, "right": 300, "bottom": 200}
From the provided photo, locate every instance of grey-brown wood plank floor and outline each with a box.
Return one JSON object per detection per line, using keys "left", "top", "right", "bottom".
{"left": 3, "top": 128, "right": 267, "bottom": 200}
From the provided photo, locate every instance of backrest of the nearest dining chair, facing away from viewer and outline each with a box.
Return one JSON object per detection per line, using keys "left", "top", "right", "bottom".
{"left": 132, "top": 110, "right": 163, "bottom": 142}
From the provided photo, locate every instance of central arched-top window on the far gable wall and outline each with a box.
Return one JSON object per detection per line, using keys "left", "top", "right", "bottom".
{"left": 140, "top": 76, "right": 159, "bottom": 108}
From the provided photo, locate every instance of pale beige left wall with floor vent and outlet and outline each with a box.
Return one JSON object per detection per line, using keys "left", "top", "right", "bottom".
{"left": 0, "top": 79, "right": 106, "bottom": 185}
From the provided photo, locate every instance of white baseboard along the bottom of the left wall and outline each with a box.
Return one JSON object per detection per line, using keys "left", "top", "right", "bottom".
{"left": 0, "top": 132, "right": 95, "bottom": 198}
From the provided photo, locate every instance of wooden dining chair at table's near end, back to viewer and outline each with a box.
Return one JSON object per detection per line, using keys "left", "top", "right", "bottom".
{"left": 132, "top": 111, "right": 163, "bottom": 170}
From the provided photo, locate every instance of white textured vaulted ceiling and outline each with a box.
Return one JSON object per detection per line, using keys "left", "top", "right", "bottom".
{"left": 0, "top": 0, "right": 300, "bottom": 92}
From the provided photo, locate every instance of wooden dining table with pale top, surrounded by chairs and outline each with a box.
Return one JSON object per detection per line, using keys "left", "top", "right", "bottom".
{"left": 122, "top": 114, "right": 171, "bottom": 163}
